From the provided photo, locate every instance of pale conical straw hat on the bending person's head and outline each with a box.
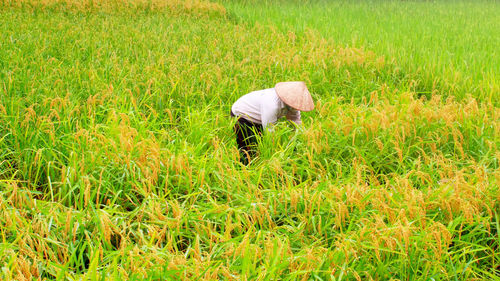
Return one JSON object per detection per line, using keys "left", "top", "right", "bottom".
{"left": 274, "top": 81, "right": 314, "bottom": 111}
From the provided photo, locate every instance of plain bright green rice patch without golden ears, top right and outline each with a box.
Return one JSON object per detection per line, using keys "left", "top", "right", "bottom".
{"left": 224, "top": 0, "right": 500, "bottom": 105}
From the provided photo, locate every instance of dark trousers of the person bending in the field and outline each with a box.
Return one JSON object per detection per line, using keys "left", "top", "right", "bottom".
{"left": 231, "top": 111, "right": 262, "bottom": 165}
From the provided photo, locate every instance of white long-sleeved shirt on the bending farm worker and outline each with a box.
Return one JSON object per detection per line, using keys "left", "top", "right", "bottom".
{"left": 231, "top": 88, "right": 301, "bottom": 128}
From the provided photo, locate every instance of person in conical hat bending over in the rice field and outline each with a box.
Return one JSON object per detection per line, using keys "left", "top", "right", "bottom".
{"left": 231, "top": 81, "right": 314, "bottom": 165}
